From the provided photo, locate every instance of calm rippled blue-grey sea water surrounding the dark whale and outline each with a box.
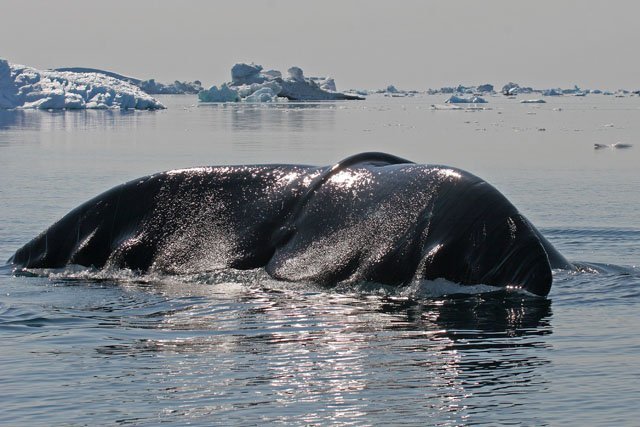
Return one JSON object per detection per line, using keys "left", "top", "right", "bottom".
{"left": 0, "top": 95, "right": 640, "bottom": 426}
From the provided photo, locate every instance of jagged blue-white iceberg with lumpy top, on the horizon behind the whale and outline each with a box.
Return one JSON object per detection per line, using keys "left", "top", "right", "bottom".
{"left": 198, "top": 63, "right": 363, "bottom": 102}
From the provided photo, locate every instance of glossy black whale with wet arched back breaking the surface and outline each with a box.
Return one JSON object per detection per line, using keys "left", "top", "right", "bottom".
{"left": 8, "top": 152, "right": 572, "bottom": 296}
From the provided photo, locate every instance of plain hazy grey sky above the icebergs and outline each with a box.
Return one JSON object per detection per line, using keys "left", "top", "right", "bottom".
{"left": 0, "top": 0, "right": 640, "bottom": 90}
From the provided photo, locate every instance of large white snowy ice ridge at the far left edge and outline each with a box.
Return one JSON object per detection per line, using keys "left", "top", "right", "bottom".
{"left": 0, "top": 58, "right": 165, "bottom": 110}
